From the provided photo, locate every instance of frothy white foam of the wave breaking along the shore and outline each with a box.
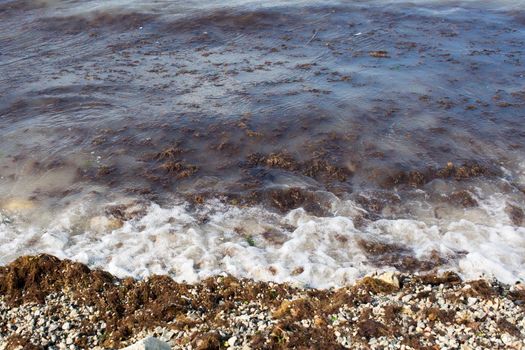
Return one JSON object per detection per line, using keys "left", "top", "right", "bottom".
{"left": 0, "top": 191, "right": 525, "bottom": 288}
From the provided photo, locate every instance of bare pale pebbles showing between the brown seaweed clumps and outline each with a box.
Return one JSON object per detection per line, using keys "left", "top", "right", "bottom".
{"left": 0, "top": 275, "right": 525, "bottom": 350}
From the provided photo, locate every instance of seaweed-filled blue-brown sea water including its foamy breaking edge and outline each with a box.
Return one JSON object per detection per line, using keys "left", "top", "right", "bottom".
{"left": 0, "top": 0, "right": 525, "bottom": 287}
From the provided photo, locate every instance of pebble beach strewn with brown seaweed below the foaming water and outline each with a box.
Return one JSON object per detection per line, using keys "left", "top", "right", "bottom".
{"left": 0, "top": 255, "right": 525, "bottom": 349}
